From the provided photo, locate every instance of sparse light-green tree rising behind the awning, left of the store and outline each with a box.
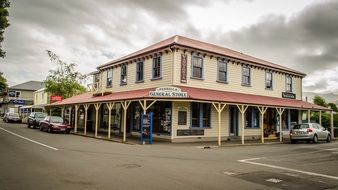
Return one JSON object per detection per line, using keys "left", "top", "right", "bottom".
{"left": 44, "top": 50, "right": 87, "bottom": 99}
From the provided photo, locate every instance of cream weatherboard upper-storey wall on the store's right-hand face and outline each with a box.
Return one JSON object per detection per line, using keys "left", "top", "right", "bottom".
{"left": 173, "top": 50, "right": 302, "bottom": 100}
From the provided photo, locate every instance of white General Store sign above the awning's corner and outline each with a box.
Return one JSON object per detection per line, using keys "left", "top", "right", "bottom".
{"left": 149, "top": 86, "right": 188, "bottom": 98}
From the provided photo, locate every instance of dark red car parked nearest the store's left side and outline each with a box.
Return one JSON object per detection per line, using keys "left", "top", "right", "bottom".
{"left": 40, "top": 116, "right": 72, "bottom": 133}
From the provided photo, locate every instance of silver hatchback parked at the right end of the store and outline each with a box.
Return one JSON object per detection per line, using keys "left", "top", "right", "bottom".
{"left": 290, "top": 123, "right": 331, "bottom": 143}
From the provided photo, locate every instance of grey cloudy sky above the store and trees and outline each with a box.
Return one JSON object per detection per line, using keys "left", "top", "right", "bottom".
{"left": 0, "top": 0, "right": 338, "bottom": 93}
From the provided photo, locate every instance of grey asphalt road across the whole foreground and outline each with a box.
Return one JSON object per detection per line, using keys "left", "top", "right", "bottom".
{"left": 0, "top": 121, "right": 338, "bottom": 190}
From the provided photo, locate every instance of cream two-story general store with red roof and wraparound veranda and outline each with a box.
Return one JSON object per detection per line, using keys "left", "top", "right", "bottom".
{"left": 52, "top": 36, "right": 329, "bottom": 144}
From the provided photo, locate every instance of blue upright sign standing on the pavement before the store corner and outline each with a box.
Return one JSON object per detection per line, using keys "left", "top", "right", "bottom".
{"left": 140, "top": 112, "right": 153, "bottom": 144}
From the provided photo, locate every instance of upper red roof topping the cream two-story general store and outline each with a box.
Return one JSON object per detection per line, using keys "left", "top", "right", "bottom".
{"left": 98, "top": 35, "right": 306, "bottom": 76}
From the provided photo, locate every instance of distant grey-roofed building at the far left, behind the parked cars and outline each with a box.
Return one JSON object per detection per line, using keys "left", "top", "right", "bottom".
{"left": 0, "top": 81, "right": 44, "bottom": 113}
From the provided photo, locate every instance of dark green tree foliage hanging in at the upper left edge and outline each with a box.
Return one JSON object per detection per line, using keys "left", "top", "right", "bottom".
{"left": 0, "top": 0, "right": 10, "bottom": 58}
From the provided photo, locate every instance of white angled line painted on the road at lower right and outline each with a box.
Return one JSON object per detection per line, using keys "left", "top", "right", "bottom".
{"left": 237, "top": 158, "right": 338, "bottom": 180}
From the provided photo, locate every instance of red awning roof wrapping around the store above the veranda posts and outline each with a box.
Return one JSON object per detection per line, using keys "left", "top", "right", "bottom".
{"left": 51, "top": 86, "right": 331, "bottom": 111}
